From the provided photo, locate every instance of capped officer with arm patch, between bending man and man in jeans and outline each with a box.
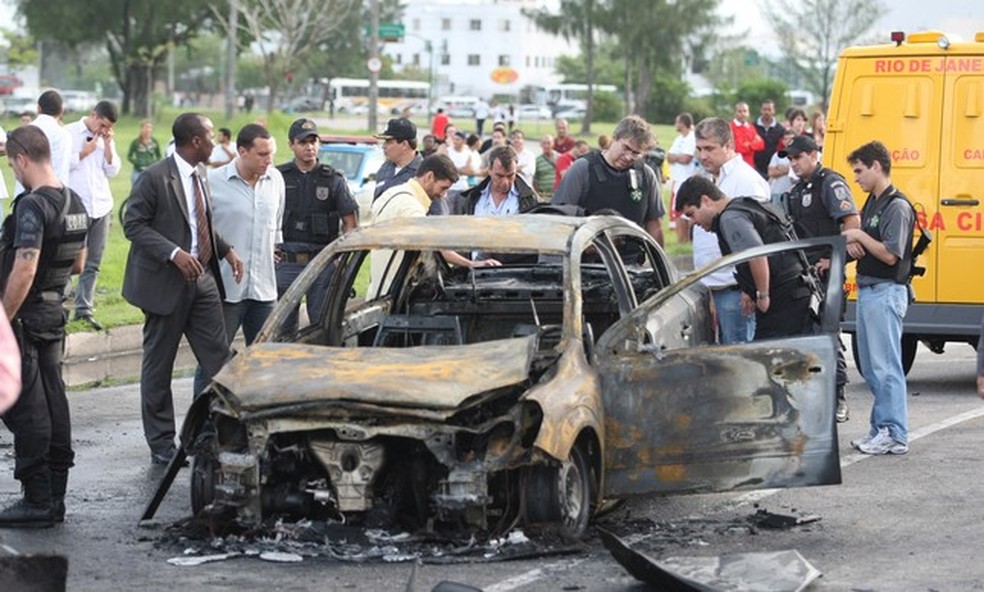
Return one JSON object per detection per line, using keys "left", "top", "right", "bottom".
{"left": 779, "top": 136, "right": 861, "bottom": 422}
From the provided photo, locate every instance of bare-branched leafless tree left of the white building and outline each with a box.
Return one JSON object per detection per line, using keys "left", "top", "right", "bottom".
{"left": 221, "top": 0, "right": 361, "bottom": 112}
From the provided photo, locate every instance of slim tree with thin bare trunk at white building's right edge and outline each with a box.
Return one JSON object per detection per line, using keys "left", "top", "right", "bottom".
{"left": 523, "top": 0, "right": 599, "bottom": 135}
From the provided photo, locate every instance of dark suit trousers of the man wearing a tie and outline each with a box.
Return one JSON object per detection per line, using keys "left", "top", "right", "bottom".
{"left": 140, "top": 272, "right": 230, "bottom": 452}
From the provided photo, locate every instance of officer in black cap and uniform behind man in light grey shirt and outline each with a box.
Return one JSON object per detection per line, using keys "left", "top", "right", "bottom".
{"left": 277, "top": 119, "right": 359, "bottom": 332}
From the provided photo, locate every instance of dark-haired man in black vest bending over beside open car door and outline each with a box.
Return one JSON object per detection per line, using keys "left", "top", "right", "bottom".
{"left": 675, "top": 176, "right": 817, "bottom": 340}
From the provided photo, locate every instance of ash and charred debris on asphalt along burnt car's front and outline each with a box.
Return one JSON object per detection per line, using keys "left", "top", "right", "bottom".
{"left": 143, "top": 506, "right": 822, "bottom": 564}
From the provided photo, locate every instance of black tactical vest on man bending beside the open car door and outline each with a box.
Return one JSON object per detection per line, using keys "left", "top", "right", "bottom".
{"left": 714, "top": 198, "right": 806, "bottom": 288}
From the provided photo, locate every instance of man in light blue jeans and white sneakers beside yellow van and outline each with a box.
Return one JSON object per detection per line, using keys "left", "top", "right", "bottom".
{"left": 842, "top": 141, "right": 915, "bottom": 454}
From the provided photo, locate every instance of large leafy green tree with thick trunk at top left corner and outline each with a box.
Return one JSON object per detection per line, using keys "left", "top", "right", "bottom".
{"left": 16, "top": 0, "right": 210, "bottom": 117}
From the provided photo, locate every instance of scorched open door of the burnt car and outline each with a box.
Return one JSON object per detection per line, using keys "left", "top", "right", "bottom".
{"left": 596, "top": 237, "right": 844, "bottom": 497}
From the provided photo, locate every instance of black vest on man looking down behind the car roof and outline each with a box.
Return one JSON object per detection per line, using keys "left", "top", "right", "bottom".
{"left": 578, "top": 152, "right": 649, "bottom": 226}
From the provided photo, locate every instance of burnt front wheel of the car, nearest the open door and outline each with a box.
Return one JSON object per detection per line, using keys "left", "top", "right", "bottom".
{"left": 526, "top": 444, "right": 594, "bottom": 536}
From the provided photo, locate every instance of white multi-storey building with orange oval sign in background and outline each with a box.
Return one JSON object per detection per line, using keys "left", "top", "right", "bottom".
{"left": 383, "top": 0, "right": 580, "bottom": 100}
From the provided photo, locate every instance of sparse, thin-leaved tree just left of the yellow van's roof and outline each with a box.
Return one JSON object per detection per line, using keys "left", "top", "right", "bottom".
{"left": 763, "top": 0, "right": 885, "bottom": 110}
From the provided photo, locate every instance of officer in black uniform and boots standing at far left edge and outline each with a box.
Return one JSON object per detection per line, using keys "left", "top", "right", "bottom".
{"left": 0, "top": 125, "right": 88, "bottom": 528}
